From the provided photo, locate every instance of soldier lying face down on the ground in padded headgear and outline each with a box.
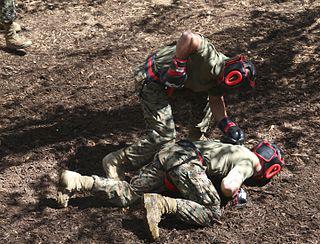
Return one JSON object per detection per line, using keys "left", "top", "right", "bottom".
{"left": 57, "top": 140, "right": 284, "bottom": 239}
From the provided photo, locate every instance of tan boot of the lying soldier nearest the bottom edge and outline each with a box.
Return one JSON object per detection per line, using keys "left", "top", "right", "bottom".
{"left": 143, "top": 193, "right": 177, "bottom": 240}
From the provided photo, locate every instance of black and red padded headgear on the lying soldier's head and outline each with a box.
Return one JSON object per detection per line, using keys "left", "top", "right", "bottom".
{"left": 244, "top": 140, "right": 284, "bottom": 186}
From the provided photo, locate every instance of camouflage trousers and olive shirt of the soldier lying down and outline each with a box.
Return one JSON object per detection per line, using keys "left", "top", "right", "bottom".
{"left": 93, "top": 140, "right": 256, "bottom": 226}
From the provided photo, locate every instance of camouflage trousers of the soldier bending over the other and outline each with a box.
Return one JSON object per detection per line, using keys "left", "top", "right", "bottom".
{"left": 125, "top": 67, "right": 212, "bottom": 168}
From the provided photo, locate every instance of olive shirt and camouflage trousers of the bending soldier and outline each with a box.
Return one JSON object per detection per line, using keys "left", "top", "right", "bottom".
{"left": 125, "top": 37, "right": 227, "bottom": 168}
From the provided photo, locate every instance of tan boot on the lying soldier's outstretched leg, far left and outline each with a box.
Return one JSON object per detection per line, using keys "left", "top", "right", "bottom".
{"left": 57, "top": 170, "right": 94, "bottom": 207}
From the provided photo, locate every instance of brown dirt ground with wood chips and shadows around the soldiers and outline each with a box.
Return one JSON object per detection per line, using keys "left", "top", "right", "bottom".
{"left": 0, "top": 0, "right": 320, "bottom": 243}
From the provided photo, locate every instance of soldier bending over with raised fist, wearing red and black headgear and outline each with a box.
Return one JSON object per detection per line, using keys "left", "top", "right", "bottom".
{"left": 104, "top": 31, "right": 255, "bottom": 179}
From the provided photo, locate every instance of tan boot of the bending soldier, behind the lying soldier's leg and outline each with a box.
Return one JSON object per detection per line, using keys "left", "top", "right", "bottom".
{"left": 102, "top": 149, "right": 130, "bottom": 180}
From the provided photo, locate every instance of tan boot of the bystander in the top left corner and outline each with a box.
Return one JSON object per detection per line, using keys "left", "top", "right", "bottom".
{"left": 5, "top": 23, "right": 32, "bottom": 50}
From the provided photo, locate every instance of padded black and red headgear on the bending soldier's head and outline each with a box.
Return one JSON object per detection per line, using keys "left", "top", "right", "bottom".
{"left": 218, "top": 55, "right": 256, "bottom": 93}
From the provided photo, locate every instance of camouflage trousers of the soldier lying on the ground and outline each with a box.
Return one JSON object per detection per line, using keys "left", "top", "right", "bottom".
{"left": 93, "top": 150, "right": 221, "bottom": 226}
